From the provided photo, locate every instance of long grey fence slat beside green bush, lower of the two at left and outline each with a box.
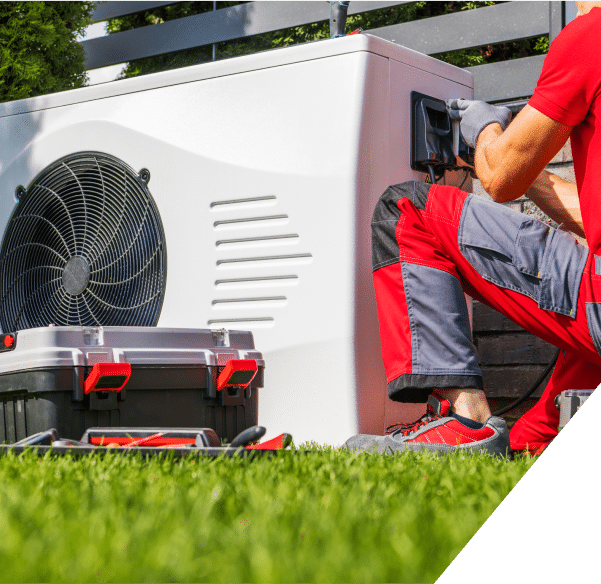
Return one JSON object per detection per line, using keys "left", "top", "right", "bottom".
{"left": 81, "top": 0, "right": 410, "bottom": 69}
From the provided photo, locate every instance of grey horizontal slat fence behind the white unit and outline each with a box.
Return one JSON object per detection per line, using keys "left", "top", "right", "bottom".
{"left": 82, "top": 0, "right": 575, "bottom": 101}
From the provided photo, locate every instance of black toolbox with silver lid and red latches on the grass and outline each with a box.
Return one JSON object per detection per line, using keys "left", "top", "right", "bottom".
{"left": 0, "top": 325, "right": 265, "bottom": 443}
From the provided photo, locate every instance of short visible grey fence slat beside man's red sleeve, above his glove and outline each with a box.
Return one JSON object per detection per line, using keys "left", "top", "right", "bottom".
{"left": 466, "top": 55, "right": 545, "bottom": 102}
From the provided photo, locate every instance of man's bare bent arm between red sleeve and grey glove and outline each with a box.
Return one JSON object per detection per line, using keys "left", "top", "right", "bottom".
{"left": 475, "top": 105, "right": 572, "bottom": 203}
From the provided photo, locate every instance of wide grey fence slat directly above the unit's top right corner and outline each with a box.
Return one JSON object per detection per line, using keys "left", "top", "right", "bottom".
{"left": 368, "top": 2, "right": 549, "bottom": 55}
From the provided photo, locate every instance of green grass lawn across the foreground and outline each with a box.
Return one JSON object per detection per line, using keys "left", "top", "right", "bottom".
{"left": 0, "top": 449, "right": 534, "bottom": 582}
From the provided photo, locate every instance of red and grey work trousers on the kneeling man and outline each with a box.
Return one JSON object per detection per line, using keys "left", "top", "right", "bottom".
{"left": 372, "top": 182, "right": 601, "bottom": 450}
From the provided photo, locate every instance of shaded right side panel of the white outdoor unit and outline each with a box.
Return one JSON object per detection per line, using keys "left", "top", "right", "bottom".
{"left": 354, "top": 59, "right": 472, "bottom": 434}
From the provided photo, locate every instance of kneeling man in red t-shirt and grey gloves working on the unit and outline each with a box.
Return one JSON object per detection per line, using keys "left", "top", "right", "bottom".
{"left": 347, "top": 2, "right": 601, "bottom": 454}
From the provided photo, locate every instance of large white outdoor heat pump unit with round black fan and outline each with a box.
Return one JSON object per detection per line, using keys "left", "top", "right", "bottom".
{"left": 0, "top": 35, "right": 473, "bottom": 444}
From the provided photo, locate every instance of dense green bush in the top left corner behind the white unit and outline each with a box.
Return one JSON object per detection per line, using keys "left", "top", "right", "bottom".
{"left": 0, "top": 0, "right": 96, "bottom": 101}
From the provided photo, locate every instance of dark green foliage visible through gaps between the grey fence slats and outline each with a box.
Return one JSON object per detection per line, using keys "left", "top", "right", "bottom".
{"left": 108, "top": 0, "right": 548, "bottom": 77}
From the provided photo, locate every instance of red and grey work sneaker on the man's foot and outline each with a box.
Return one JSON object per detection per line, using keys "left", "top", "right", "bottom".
{"left": 345, "top": 393, "right": 510, "bottom": 456}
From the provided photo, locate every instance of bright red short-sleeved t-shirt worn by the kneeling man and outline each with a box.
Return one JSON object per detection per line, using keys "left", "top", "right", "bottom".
{"left": 529, "top": 8, "right": 601, "bottom": 254}
